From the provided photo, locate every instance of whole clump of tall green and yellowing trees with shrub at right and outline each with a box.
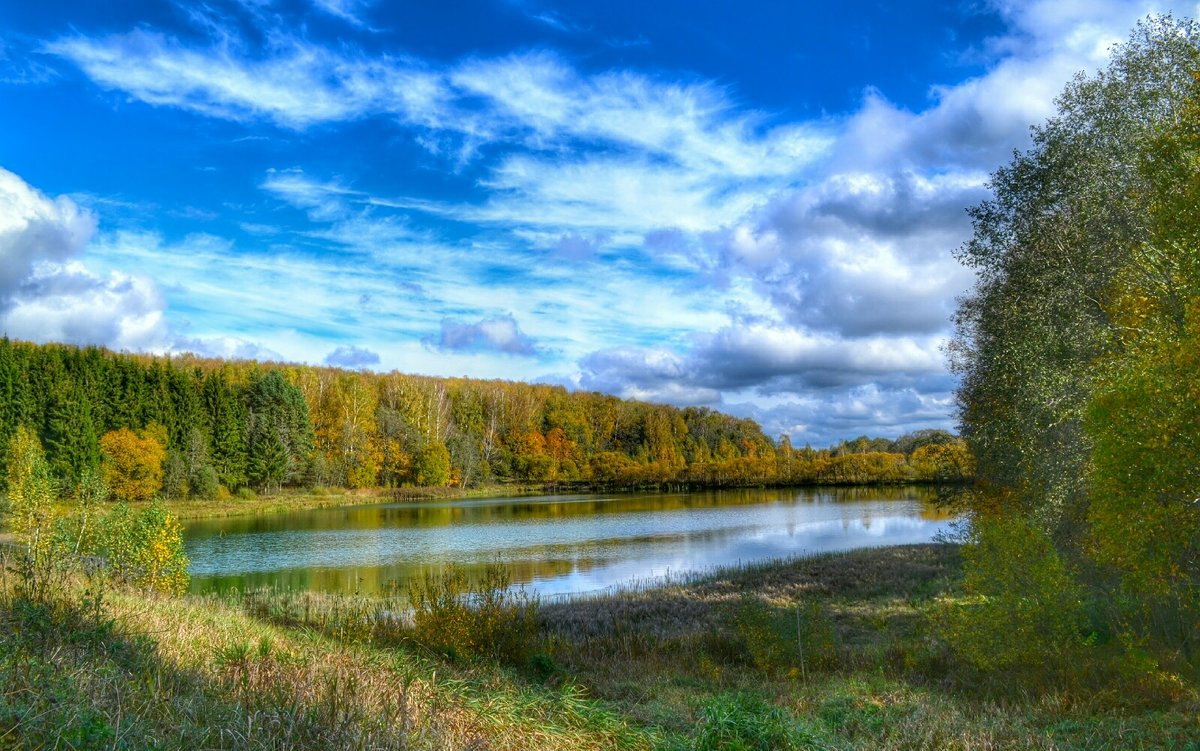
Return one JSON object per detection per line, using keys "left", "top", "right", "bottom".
{"left": 952, "top": 18, "right": 1200, "bottom": 667}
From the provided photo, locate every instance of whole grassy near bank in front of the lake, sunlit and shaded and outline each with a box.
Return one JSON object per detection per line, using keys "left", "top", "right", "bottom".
{"left": 0, "top": 545, "right": 1200, "bottom": 751}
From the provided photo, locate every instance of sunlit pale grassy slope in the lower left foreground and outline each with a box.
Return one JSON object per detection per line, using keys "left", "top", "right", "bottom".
{"left": 0, "top": 571, "right": 652, "bottom": 750}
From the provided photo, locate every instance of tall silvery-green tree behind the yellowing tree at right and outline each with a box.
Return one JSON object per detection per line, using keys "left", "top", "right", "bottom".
{"left": 952, "top": 18, "right": 1200, "bottom": 532}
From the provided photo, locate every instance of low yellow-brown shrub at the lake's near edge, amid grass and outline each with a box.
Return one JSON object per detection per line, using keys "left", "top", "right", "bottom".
{"left": 408, "top": 564, "right": 539, "bottom": 665}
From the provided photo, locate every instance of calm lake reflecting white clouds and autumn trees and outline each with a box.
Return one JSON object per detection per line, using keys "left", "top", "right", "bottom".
{"left": 184, "top": 487, "right": 954, "bottom": 595}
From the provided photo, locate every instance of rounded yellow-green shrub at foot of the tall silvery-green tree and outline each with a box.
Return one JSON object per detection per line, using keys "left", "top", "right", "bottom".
{"left": 940, "top": 515, "right": 1084, "bottom": 679}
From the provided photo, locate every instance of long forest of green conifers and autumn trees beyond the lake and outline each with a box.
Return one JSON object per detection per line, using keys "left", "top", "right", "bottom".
{"left": 0, "top": 338, "right": 973, "bottom": 498}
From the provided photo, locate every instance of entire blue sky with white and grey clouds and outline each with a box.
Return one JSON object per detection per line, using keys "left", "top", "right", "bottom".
{"left": 0, "top": 0, "right": 1198, "bottom": 445}
